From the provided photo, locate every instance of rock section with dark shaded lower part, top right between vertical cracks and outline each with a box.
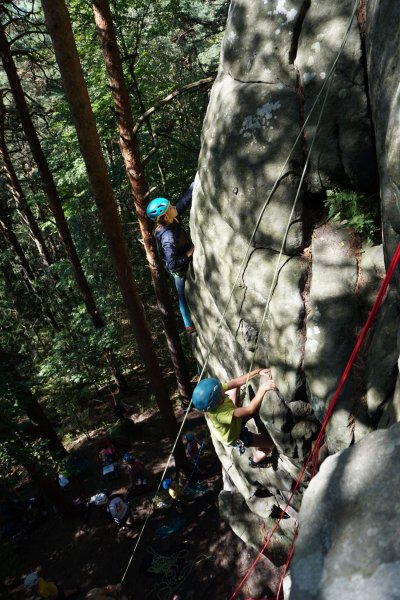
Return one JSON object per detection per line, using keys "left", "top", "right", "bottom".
{"left": 295, "top": 0, "right": 378, "bottom": 193}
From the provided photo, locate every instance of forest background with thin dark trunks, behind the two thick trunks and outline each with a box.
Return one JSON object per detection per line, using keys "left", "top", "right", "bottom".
{"left": 0, "top": 0, "right": 229, "bottom": 528}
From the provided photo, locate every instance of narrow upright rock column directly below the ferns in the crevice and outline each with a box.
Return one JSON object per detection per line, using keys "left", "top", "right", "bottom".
{"left": 304, "top": 224, "right": 361, "bottom": 450}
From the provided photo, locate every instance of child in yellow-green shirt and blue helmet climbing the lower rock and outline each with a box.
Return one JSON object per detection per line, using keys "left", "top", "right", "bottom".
{"left": 192, "top": 369, "right": 277, "bottom": 467}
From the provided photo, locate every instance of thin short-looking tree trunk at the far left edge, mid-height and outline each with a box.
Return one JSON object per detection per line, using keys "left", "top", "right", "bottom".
{"left": 0, "top": 95, "right": 52, "bottom": 267}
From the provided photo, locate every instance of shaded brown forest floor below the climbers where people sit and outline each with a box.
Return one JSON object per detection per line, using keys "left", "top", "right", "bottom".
{"left": 3, "top": 364, "right": 279, "bottom": 600}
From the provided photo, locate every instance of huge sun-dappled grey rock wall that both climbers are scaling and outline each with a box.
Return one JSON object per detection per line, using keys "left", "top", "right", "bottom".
{"left": 187, "top": 0, "right": 400, "bottom": 584}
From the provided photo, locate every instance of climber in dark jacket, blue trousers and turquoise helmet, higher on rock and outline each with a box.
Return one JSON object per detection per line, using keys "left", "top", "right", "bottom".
{"left": 146, "top": 182, "right": 196, "bottom": 334}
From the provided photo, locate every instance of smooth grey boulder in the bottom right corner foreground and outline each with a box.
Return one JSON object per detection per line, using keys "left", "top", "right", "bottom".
{"left": 290, "top": 423, "right": 400, "bottom": 600}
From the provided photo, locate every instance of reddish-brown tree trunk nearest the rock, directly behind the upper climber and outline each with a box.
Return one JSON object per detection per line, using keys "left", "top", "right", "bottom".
{"left": 93, "top": 0, "right": 192, "bottom": 402}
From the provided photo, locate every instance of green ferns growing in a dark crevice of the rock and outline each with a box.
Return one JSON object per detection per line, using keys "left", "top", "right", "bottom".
{"left": 325, "top": 190, "right": 379, "bottom": 243}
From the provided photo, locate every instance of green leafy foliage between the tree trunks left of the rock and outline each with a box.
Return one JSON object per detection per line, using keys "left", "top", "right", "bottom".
{"left": 0, "top": 0, "right": 229, "bottom": 488}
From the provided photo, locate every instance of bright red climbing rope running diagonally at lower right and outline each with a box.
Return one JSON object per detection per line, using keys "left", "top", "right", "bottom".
{"left": 229, "top": 243, "right": 400, "bottom": 600}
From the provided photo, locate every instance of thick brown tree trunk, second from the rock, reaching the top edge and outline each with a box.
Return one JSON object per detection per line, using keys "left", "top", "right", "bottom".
{"left": 42, "top": 0, "right": 190, "bottom": 473}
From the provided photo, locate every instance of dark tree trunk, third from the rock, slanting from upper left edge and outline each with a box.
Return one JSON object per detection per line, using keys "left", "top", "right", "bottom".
{"left": 0, "top": 19, "right": 104, "bottom": 328}
